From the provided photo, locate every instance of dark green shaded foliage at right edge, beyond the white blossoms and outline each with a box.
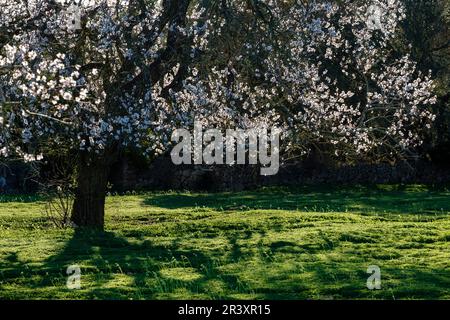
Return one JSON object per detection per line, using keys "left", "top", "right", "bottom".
{"left": 403, "top": 0, "right": 450, "bottom": 165}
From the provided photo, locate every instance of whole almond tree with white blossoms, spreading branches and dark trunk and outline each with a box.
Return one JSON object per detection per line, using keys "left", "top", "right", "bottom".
{"left": 0, "top": 0, "right": 434, "bottom": 227}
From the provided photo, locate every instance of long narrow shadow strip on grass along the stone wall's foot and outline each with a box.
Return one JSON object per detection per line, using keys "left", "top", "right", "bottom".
{"left": 144, "top": 185, "right": 450, "bottom": 214}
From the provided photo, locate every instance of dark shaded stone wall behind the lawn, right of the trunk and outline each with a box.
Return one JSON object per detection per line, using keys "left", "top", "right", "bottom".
{"left": 111, "top": 157, "right": 450, "bottom": 191}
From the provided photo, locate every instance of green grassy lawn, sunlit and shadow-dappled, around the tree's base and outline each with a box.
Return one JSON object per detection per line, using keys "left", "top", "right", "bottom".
{"left": 0, "top": 186, "right": 450, "bottom": 299}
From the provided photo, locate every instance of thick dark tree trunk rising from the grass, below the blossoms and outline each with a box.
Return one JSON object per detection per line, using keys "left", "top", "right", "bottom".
{"left": 71, "top": 155, "right": 112, "bottom": 229}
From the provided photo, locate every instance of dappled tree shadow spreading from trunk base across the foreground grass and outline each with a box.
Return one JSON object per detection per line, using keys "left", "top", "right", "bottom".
{"left": 0, "top": 229, "right": 450, "bottom": 299}
